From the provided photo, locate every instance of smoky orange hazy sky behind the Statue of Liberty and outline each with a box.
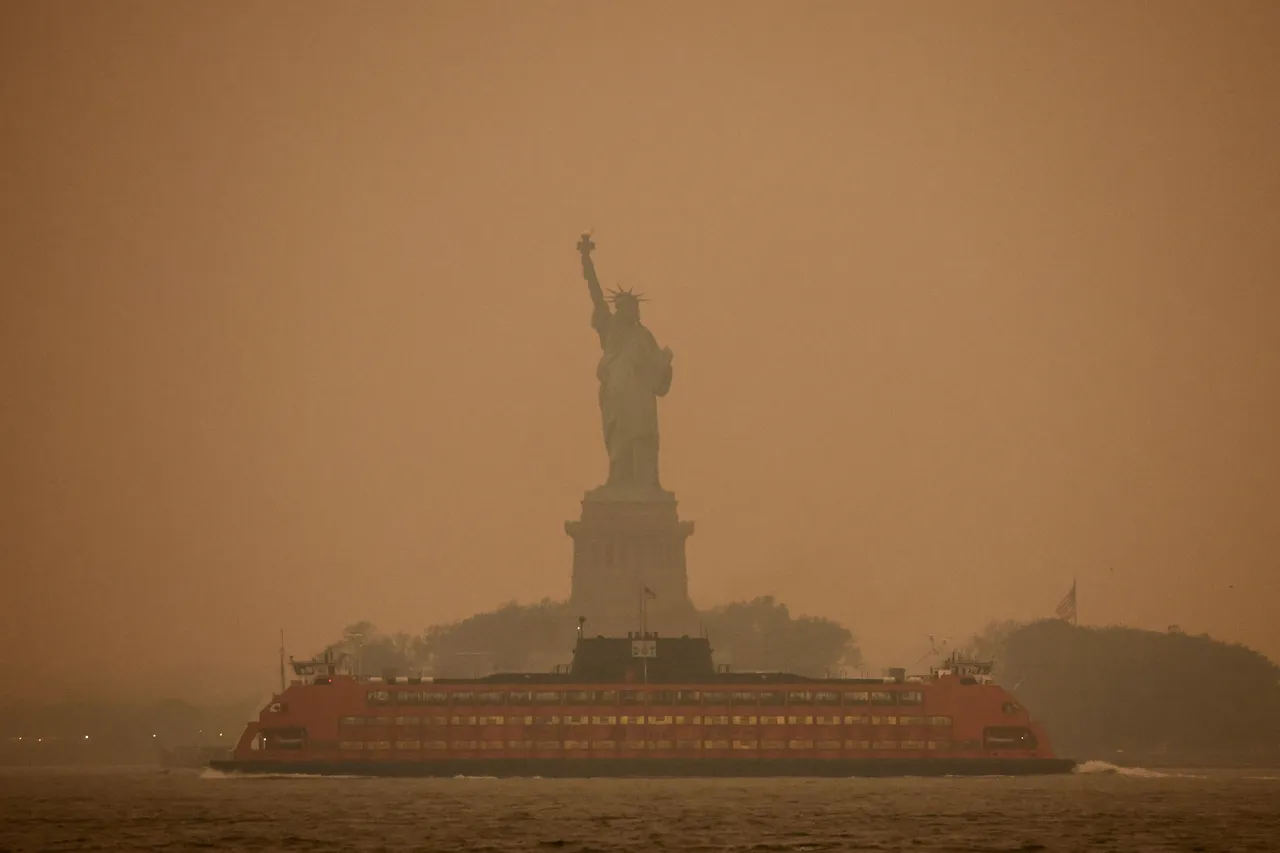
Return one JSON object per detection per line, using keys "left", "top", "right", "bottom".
{"left": 0, "top": 0, "right": 1280, "bottom": 695}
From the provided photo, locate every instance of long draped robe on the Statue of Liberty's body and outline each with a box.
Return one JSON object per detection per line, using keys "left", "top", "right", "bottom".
{"left": 591, "top": 306, "right": 671, "bottom": 488}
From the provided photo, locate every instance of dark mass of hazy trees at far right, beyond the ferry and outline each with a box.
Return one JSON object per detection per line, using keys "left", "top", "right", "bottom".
{"left": 974, "top": 620, "right": 1280, "bottom": 761}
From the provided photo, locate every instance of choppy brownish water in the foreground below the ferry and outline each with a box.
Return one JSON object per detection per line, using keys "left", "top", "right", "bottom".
{"left": 0, "top": 762, "right": 1280, "bottom": 853}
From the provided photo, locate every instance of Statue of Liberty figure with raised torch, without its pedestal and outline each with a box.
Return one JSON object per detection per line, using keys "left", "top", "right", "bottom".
{"left": 577, "top": 234, "right": 672, "bottom": 500}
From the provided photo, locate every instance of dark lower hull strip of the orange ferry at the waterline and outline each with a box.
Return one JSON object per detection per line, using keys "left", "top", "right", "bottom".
{"left": 210, "top": 758, "right": 1075, "bottom": 779}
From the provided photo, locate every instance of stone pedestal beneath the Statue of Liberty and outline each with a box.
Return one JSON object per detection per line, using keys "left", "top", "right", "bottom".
{"left": 564, "top": 488, "right": 699, "bottom": 637}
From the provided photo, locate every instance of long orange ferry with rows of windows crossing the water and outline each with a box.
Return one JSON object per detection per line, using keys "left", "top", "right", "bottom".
{"left": 210, "top": 633, "right": 1075, "bottom": 777}
